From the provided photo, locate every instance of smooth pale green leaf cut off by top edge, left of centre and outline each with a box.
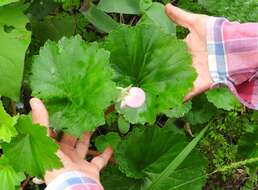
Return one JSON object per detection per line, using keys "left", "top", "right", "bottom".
{"left": 98, "top": 0, "right": 141, "bottom": 14}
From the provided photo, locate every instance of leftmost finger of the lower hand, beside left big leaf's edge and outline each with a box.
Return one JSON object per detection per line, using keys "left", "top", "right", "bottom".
{"left": 30, "top": 98, "right": 56, "bottom": 138}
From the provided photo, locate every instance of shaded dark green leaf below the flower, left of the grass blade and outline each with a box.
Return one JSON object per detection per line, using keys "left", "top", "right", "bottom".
{"left": 115, "top": 126, "right": 183, "bottom": 179}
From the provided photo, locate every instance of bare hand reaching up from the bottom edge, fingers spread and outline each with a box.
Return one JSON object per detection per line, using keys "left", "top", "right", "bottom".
{"left": 30, "top": 98, "right": 112, "bottom": 185}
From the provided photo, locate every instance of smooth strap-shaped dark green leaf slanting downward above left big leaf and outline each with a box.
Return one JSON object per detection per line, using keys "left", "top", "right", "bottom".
{"left": 82, "top": 4, "right": 119, "bottom": 33}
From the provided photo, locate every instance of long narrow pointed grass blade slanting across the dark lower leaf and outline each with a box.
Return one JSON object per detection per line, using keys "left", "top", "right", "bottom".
{"left": 147, "top": 127, "right": 208, "bottom": 190}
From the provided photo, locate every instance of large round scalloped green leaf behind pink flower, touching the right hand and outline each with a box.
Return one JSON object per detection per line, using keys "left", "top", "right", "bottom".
{"left": 105, "top": 24, "right": 196, "bottom": 123}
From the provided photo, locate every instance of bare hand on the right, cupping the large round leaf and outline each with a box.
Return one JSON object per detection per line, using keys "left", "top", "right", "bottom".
{"left": 166, "top": 4, "right": 213, "bottom": 100}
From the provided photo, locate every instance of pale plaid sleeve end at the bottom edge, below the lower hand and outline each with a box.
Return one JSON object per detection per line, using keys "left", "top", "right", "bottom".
{"left": 45, "top": 171, "right": 104, "bottom": 190}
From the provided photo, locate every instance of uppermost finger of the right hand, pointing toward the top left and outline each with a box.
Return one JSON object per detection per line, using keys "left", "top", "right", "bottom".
{"left": 165, "top": 4, "right": 196, "bottom": 29}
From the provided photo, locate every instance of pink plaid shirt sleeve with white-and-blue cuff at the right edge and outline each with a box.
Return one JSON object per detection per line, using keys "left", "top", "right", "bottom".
{"left": 207, "top": 17, "right": 258, "bottom": 110}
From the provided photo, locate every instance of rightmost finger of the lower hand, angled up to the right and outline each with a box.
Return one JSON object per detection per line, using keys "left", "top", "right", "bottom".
{"left": 91, "top": 147, "right": 113, "bottom": 171}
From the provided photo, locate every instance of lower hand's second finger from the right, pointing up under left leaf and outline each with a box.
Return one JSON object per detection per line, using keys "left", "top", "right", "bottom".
{"left": 76, "top": 132, "right": 91, "bottom": 159}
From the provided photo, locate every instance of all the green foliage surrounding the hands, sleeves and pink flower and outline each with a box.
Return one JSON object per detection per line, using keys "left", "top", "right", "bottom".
{"left": 0, "top": 0, "right": 258, "bottom": 190}
